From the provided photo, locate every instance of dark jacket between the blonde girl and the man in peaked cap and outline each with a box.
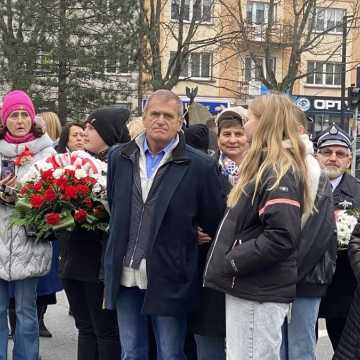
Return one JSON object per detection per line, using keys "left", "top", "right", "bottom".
{"left": 296, "top": 174, "right": 337, "bottom": 297}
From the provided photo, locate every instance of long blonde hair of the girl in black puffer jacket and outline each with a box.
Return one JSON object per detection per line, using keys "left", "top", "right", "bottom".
{"left": 228, "top": 94, "right": 312, "bottom": 211}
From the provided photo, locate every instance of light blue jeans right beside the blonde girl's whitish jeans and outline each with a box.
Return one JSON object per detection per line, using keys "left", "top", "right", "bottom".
{"left": 280, "top": 297, "right": 321, "bottom": 360}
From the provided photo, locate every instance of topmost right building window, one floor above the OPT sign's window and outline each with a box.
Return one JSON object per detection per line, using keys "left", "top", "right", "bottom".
{"left": 314, "top": 8, "right": 345, "bottom": 34}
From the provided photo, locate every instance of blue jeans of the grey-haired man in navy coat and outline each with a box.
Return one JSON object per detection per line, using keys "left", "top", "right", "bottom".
{"left": 116, "top": 287, "right": 187, "bottom": 360}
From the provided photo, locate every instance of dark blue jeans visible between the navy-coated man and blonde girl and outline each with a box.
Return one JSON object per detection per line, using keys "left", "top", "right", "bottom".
{"left": 195, "top": 335, "right": 225, "bottom": 360}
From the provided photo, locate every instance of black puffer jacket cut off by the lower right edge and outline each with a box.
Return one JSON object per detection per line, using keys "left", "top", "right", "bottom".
{"left": 333, "top": 224, "right": 360, "bottom": 360}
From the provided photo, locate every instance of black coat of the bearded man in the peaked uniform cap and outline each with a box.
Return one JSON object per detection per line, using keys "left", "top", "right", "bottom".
{"left": 319, "top": 174, "right": 360, "bottom": 318}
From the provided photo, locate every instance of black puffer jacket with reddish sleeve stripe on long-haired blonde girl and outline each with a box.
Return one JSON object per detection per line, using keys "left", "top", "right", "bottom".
{"left": 204, "top": 172, "right": 304, "bottom": 303}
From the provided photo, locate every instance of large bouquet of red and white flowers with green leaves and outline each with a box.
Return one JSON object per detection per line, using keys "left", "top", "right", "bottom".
{"left": 11, "top": 151, "right": 109, "bottom": 241}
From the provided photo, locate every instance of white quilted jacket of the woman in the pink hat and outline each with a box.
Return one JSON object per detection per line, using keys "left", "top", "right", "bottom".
{"left": 0, "top": 135, "right": 55, "bottom": 281}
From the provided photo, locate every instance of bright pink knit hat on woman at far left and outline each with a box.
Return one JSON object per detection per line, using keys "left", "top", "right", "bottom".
{"left": 0, "top": 90, "right": 35, "bottom": 126}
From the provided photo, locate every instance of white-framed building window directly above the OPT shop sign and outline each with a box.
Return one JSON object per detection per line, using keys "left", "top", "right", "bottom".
{"left": 306, "top": 61, "right": 342, "bottom": 86}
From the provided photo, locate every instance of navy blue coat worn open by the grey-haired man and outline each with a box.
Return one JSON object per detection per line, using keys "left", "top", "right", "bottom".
{"left": 104, "top": 135, "right": 225, "bottom": 317}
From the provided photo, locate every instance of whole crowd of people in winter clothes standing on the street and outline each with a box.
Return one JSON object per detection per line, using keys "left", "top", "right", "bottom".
{"left": 0, "top": 90, "right": 360, "bottom": 360}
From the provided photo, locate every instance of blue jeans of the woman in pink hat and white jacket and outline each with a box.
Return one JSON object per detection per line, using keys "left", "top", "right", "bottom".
{"left": 0, "top": 278, "right": 39, "bottom": 360}
